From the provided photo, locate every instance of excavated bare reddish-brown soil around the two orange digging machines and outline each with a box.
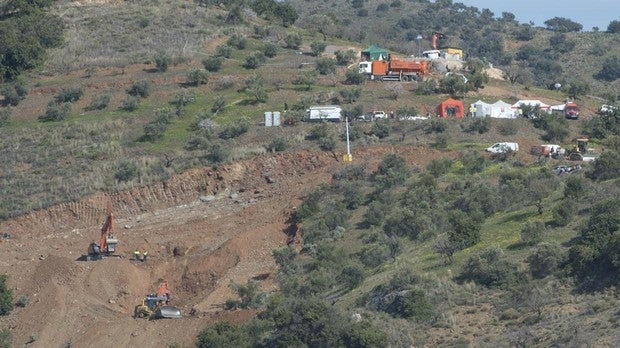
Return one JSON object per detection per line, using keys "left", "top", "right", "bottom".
{"left": 0, "top": 146, "right": 445, "bottom": 347}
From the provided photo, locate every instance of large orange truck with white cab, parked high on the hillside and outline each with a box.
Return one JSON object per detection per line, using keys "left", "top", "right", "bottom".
{"left": 358, "top": 59, "right": 429, "bottom": 81}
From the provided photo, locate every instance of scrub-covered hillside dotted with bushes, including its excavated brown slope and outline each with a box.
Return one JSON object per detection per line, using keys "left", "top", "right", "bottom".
{"left": 0, "top": 1, "right": 620, "bottom": 347}
